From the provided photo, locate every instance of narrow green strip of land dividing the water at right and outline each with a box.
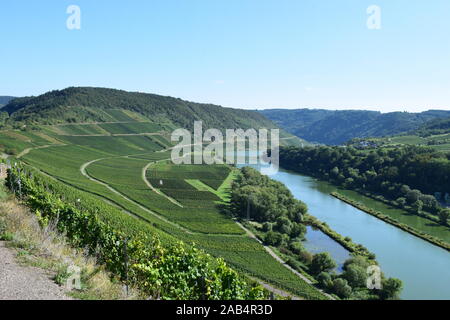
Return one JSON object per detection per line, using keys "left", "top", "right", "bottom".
{"left": 330, "top": 192, "right": 450, "bottom": 251}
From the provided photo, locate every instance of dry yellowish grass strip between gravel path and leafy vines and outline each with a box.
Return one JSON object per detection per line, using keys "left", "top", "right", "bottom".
{"left": 0, "top": 197, "right": 140, "bottom": 300}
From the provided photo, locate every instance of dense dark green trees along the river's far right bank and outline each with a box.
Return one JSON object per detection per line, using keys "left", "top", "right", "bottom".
{"left": 280, "top": 146, "right": 450, "bottom": 224}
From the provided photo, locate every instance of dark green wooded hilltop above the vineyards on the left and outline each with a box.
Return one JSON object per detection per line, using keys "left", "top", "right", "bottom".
{"left": 3, "top": 87, "right": 275, "bottom": 129}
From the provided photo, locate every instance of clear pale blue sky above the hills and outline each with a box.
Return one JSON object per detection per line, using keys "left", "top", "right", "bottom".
{"left": 0, "top": 0, "right": 450, "bottom": 112}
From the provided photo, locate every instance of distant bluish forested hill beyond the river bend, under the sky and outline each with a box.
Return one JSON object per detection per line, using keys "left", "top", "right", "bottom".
{"left": 260, "top": 109, "right": 450, "bottom": 145}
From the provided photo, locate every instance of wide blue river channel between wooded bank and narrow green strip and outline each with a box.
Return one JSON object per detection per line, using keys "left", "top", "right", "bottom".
{"left": 271, "top": 169, "right": 450, "bottom": 299}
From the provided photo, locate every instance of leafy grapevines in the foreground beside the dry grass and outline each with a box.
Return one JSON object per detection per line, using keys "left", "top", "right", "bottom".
{"left": 7, "top": 167, "right": 264, "bottom": 299}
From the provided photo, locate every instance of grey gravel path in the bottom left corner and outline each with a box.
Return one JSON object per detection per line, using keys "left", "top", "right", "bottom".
{"left": 0, "top": 241, "right": 72, "bottom": 300}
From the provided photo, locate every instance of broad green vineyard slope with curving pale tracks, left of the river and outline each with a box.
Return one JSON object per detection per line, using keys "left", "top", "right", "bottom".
{"left": 0, "top": 119, "right": 325, "bottom": 299}
